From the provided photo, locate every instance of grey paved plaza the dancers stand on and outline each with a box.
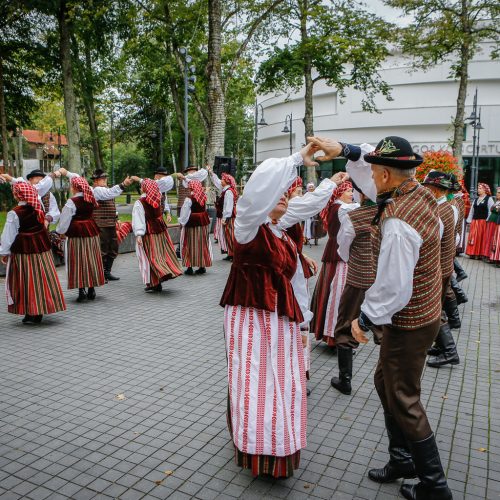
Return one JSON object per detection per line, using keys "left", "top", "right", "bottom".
{"left": 0, "top": 240, "right": 500, "bottom": 500}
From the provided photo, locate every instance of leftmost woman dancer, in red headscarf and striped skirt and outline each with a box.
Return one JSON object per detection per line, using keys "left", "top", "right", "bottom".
{"left": 0, "top": 182, "right": 66, "bottom": 323}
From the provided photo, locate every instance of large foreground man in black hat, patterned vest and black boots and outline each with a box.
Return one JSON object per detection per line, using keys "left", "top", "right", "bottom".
{"left": 309, "top": 136, "right": 452, "bottom": 500}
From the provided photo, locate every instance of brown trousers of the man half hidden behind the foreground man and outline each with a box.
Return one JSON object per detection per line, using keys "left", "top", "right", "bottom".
{"left": 333, "top": 284, "right": 382, "bottom": 349}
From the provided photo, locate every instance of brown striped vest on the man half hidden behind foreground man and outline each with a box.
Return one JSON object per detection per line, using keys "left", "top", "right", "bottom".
{"left": 346, "top": 205, "right": 377, "bottom": 290}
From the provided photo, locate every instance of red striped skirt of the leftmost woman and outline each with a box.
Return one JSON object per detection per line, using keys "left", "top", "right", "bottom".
{"left": 5, "top": 250, "right": 66, "bottom": 316}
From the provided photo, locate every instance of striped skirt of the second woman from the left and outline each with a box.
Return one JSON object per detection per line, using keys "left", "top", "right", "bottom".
{"left": 65, "top": 235, "right": 104, "bottom": 290}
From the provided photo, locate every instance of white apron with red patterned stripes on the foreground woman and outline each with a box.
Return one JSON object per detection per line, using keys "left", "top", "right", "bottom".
{"left": 224, "top": 306, "right": 307, "bottom": 457}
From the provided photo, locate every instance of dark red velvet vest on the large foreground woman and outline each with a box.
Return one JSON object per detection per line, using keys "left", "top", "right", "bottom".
{"left": 220, "top": 224, "right": 304, "bottom": 323}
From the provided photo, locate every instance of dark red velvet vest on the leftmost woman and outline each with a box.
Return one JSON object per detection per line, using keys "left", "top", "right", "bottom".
{"left": 10, "top": 205, "right": 50, "bottom": 253}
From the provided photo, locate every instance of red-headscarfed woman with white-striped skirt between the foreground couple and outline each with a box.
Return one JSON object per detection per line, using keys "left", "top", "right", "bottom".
{"left": 310, "top": 181, "right": 358, "bottom": 347}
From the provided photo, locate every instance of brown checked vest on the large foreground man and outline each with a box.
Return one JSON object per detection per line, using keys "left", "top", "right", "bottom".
{"left": 372, "top": 180, "right": 442, "bottom": 330}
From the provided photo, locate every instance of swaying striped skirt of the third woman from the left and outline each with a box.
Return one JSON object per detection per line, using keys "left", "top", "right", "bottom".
{"left": 135, "top": 232, "right": 182, "bottom": 286}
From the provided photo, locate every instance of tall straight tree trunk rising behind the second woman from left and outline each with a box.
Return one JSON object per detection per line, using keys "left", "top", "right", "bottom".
{"left": 58, "top": 0, "right": 82, "bottom": 173}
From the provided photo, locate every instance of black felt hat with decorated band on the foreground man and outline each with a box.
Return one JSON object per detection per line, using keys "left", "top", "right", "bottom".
{"left": 364, "top": 135, "right": 424, "bottom": 169}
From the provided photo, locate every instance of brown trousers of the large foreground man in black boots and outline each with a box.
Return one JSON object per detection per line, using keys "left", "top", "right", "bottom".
{"left": 374, "top": 319, "right": 441, "bottom": 441}
